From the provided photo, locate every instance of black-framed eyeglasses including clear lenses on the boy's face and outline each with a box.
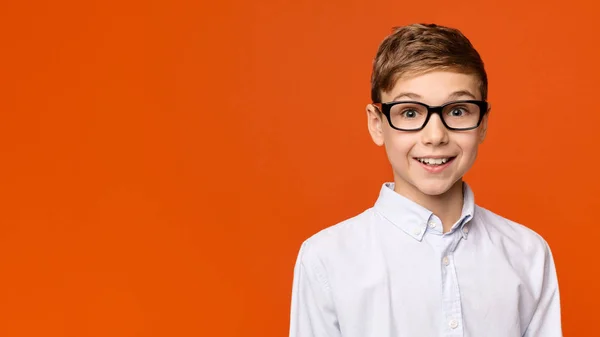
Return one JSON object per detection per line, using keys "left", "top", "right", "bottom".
{"left": 373, "top": 100, "right": 489, "bottom": 131}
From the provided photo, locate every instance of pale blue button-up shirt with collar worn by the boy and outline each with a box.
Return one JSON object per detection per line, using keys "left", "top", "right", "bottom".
{"left": 290, "top": 183, "right": 562, "bottom": 337}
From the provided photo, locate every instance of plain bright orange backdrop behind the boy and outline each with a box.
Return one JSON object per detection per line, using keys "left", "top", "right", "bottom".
{"left": 0, "top": 0, "right": 600, "bottom": 337}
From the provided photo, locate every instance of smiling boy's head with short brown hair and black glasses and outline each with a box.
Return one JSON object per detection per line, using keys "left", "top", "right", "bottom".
{"left": 367, "top": 24, "right": 489, "bottom": 199}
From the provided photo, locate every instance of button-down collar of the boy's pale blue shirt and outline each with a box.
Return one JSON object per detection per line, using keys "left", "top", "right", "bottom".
{"left": 375, "top": 182, "right": 475, "bottom": 241}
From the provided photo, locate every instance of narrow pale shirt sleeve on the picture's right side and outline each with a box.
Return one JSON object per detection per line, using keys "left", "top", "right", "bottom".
{"left": 523, "top": 242, "right": 562, "bottom": 337}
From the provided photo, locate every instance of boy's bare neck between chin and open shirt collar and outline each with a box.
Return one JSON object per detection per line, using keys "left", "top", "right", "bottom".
{"left": 394, "top": 179, "right": 464, "bottom": 233}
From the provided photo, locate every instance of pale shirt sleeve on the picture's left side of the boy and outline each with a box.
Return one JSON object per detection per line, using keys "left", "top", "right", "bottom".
{"left": 290, "top": 242, "right": 341, "bottom": 337}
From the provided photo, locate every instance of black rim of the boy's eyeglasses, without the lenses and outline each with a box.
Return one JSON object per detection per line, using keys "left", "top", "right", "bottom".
{"left": 373, "top": 100, "right": 490, "bottom": 131}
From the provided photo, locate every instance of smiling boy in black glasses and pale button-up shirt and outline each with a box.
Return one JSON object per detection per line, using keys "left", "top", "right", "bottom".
{"left": 290, "top": 24, "right": 562, "bottom": 337}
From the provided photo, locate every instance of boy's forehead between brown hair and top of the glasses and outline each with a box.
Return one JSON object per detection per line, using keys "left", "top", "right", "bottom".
{"left": 381, "top": 70, "right": 481, "bottom": 104}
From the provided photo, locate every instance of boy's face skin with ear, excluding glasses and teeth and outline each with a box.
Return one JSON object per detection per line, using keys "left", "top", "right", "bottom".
{"left": 367, "top": 71, "right": 487, "bottom": 198}
